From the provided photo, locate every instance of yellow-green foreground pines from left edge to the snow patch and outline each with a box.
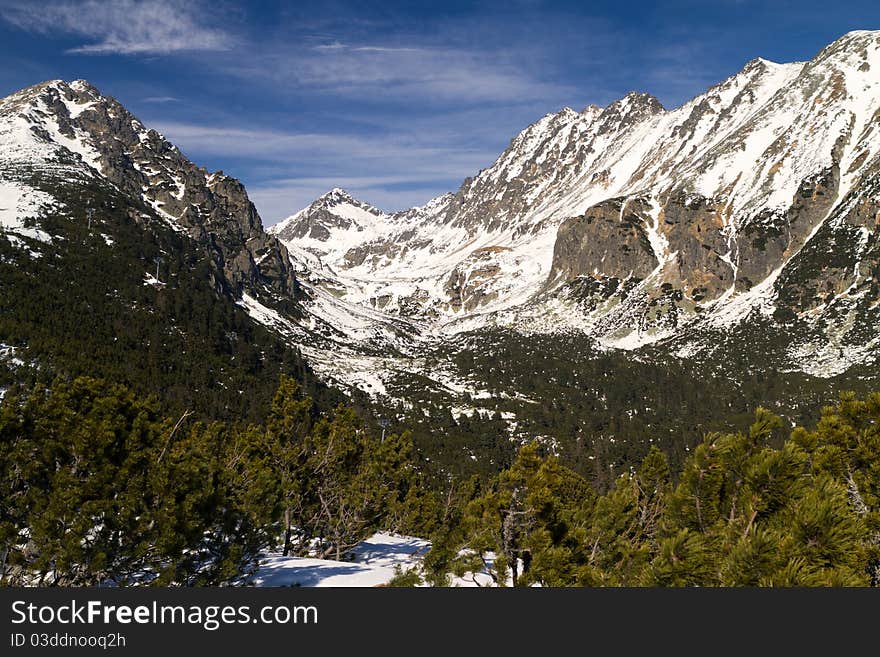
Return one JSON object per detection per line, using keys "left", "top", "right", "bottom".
{"left": 0, "top": 377, "right": 420, "bottom": 586}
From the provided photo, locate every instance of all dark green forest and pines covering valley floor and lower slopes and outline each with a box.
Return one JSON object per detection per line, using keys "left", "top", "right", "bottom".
{"left": 0, "top": 173, "right": 880, "bottom": 586}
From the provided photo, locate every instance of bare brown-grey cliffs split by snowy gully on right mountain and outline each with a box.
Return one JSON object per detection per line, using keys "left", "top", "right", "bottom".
{"left": 548, "top": 158, "right": 839, "bottom": 304}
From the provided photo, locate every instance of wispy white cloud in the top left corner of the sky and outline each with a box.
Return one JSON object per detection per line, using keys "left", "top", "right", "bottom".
{"left": 0, "top": 0, "right": 233, "bottom": 55}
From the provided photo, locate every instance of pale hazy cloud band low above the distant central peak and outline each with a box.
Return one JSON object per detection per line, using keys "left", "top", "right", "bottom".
{"left": 153, "top": 122, "right": 498, "bottom": 224}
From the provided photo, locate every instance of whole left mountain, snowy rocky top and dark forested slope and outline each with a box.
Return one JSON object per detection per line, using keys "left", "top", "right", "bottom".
{"left": 0, "top": 80, "right": 341, "bottom": 419}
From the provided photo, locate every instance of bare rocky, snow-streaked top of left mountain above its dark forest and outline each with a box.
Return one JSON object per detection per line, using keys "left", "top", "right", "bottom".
{"left": 0, "top": 80, "right": 296, "bottom": 295}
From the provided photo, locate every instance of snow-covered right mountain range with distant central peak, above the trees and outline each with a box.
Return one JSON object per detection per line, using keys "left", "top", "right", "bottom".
{"left": 270, "top": 31, "right": 880, "bottom": 375}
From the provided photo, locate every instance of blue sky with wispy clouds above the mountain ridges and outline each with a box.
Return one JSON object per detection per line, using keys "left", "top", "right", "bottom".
{"left": 0, "top": 0, "right": 880, "bottom": 225}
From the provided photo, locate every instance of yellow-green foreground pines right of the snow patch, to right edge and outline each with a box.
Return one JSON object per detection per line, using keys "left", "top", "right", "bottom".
{"left": 426, "top": 394, "right": 880, "bottom": 586}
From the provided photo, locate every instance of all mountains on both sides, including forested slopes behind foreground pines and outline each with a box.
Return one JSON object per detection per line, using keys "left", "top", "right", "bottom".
{"left": 0, "top": 32, "right": 880, "bottom": 480}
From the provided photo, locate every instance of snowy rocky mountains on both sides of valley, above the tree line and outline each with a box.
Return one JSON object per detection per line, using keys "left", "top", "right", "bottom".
{"left": 0, "top": 32, "right": 880, "bottom": 426}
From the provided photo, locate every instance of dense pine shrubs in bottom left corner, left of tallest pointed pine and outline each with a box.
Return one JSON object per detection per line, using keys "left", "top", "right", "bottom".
{"left": 0, "top": 378, "right": 271, "bottom": 585}
